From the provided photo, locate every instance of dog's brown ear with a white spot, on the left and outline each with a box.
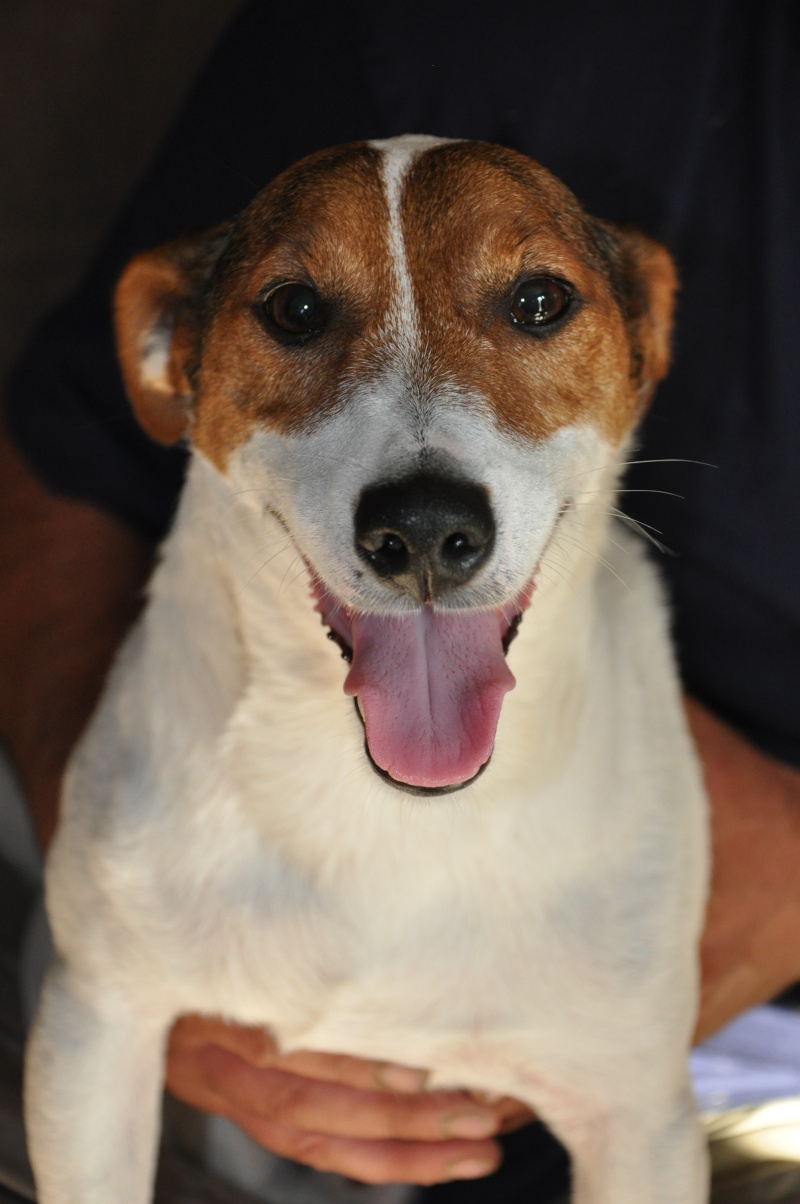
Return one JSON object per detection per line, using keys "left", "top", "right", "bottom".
{"left": 114, "top": 223, "right": 231, "bottom": 443}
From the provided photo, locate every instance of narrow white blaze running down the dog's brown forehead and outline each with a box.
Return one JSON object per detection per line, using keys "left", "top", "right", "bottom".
{"left": 370, "top": 134, "right": 449, "bottom": 360}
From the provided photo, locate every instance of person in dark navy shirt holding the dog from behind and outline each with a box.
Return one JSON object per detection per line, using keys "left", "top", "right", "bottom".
{"left": 0, "top": 0, "right": 800, "bottom": 1204}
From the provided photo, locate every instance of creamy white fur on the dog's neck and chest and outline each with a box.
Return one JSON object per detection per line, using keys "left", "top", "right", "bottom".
{"left": 45, "top": 452, "right": 705, "bottom": 1092}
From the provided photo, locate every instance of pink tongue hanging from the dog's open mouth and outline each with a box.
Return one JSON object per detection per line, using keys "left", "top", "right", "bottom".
{"left": 345, "top": 607, "right": 516, "bottom": 786}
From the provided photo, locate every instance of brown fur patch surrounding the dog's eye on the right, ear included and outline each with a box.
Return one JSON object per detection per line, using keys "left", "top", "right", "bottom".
{"left": 402, "top": 142, "right": 675, "bottom": 444}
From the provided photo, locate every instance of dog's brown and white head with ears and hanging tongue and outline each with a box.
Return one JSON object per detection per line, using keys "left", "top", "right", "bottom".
{"left": 117, "top": 137, "right": 675, "bottom": 791}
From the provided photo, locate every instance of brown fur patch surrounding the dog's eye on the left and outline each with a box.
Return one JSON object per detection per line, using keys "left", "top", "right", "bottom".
{"left": 193, "top": 144, "right": 392, "bottom": 467}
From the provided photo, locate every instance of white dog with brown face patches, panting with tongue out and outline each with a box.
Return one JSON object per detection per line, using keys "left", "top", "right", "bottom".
{"left": 27, "top": 136, "right": 708, "bottom": 1204}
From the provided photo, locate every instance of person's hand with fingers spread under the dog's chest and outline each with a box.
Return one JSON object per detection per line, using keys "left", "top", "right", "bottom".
{"left": 167, "top": 1016, "right": 530, "bottom": 1184}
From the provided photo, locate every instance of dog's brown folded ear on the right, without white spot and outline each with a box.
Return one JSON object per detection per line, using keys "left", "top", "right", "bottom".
{"left": 595, "top": 222, "right": 678, "bottom": 408}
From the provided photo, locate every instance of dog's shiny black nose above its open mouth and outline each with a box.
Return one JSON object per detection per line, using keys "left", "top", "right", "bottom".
{"left": 355, "top": 473, "right": 494, "bottom": 602}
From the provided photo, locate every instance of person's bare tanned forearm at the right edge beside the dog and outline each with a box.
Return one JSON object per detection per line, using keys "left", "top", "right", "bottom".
{"left": 687, "top": 701, "right": 800, "bottom": 1040}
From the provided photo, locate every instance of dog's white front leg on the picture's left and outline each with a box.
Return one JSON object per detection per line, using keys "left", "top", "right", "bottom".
{"left": 25, "top": 962, "right": 167, "bottom": 1204}
